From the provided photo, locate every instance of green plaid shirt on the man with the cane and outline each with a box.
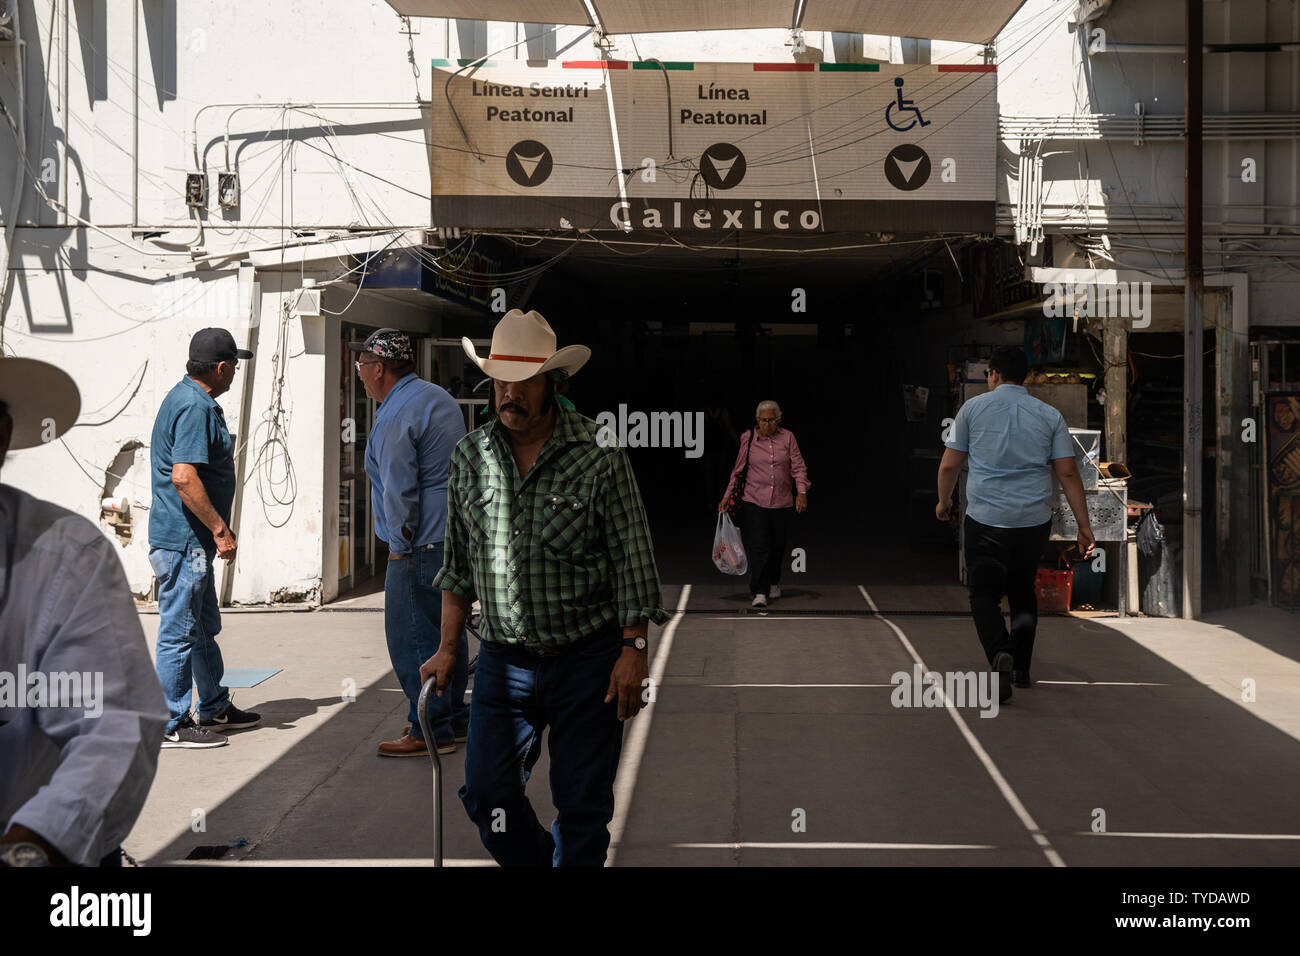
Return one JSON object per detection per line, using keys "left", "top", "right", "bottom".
{"left": 433, "top": 407, "right": 668, "bottom": 650}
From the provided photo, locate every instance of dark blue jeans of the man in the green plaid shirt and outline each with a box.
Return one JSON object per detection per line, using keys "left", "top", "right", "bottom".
{"left": 460, "top": 628, "right": 623, "bottom": 866}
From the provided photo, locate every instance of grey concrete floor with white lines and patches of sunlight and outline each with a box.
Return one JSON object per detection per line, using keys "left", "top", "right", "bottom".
{"left": 125, "top": 575, "right": 1300, "bottom": 866}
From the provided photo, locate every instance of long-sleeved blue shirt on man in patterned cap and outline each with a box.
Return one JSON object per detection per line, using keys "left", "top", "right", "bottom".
{"left": 365, "top": 372, "right": 465, "bottom": 554}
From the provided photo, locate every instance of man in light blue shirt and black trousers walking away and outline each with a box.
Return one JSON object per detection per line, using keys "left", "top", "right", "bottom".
{"left": 935, "top": 349, "right": 1096, "bottom": 702}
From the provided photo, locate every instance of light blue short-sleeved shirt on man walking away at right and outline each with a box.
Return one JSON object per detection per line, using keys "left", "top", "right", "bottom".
{"left": 946, "top": 385, "right": 1074, "bottom": 528}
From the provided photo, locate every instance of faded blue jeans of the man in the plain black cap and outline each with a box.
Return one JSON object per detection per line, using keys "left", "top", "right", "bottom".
{"left": 150, "top": 548, "right": 230, "bottom": 734}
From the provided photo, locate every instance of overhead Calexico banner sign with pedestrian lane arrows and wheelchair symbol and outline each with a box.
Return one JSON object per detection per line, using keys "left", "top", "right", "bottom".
{"left": 430, "top": 61, "right": 997, "bottom": 233}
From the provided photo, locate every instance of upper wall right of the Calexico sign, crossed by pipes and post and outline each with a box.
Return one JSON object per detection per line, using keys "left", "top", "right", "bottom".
{"left": 998, "top": 0, "right": 1300, "bottom": 325}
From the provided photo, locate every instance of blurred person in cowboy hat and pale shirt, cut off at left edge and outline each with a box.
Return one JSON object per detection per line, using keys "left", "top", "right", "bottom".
{"left": 0, "top": 358, "right": 166, "bottom": 866}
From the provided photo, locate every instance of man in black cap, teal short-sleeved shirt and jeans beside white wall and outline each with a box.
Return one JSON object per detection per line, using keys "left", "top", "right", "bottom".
{"left": 150, "top": 329, "right": 261, "bottom": 749}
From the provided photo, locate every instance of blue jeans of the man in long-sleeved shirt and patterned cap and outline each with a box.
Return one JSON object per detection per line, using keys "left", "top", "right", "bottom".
{"left": 384, "top": 541, "right": 469, "bottom": 743}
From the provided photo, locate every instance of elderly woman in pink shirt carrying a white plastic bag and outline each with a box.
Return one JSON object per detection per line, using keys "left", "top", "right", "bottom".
{"left": 718, "top": 401, "right": 811, "bottom": 607}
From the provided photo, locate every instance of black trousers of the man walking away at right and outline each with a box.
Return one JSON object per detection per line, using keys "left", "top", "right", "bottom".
{"left": 966, "top": 515, "right": 1052, "bottom": 671}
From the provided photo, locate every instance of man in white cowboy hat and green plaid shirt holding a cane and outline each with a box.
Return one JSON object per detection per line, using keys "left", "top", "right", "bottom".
{"left": 420, "top": 310, "right": 668, "bottom": 866}
